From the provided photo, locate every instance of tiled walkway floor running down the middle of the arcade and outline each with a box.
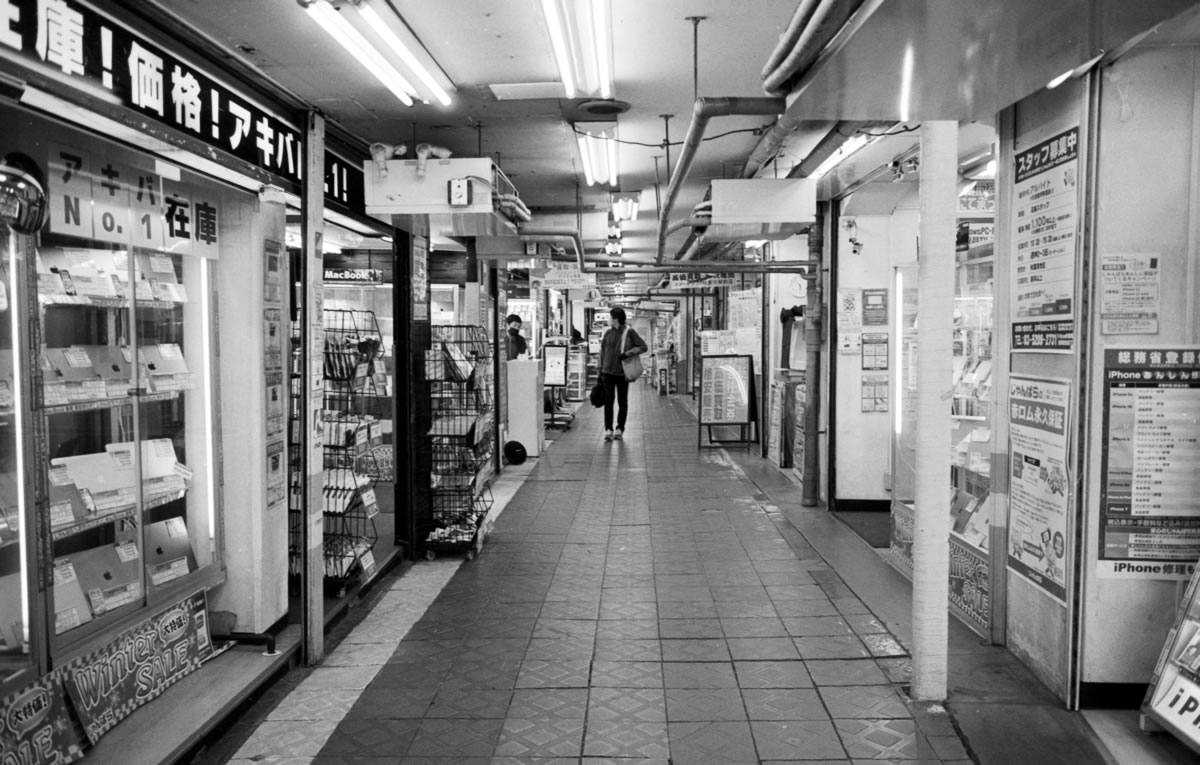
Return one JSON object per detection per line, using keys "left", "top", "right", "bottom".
{"left": 232, "top": 385, "right": 970, "bottom": 765}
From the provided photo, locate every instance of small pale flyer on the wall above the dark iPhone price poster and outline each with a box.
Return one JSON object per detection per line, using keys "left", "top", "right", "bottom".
{"left": 1100, "top": 254, "right": 1162, "bottom": 335}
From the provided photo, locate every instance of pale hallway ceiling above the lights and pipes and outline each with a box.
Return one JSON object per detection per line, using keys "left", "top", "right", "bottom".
{"left": 140, "top": 0, "right": 1194, "bottom": 270}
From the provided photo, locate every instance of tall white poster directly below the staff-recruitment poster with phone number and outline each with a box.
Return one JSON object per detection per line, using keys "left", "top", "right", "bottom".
{"left": 1008, "top": 374, "right": 1070, "bottom": 602}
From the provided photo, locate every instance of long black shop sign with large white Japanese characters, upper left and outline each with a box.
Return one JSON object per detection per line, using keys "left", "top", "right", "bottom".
{"left": 0, "top": 0, "right": 365, "bottom": 212}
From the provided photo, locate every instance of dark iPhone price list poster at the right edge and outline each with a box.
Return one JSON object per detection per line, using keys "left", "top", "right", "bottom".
{"left": 1098, "top": 347, "right": 1200, "bottom": 579}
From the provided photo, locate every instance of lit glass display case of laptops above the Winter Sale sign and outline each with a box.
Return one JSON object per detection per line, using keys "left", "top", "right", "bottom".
{"left": 0, "top": 103, "right": 226, "bottom": 661}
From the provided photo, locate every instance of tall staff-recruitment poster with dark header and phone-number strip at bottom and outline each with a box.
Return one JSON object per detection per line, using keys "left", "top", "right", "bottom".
{"left": 1009, "top": 127, "right": 1079, "bottom": 353}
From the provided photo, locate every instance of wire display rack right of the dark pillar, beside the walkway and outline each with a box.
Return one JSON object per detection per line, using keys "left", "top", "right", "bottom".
{"left": 424, "top": 325, "right": 496, "bottom": 560}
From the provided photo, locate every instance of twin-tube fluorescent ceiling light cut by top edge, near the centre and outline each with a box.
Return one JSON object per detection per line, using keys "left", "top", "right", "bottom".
{"left": 541, "top": 0, "right": 612, "bottom": 98}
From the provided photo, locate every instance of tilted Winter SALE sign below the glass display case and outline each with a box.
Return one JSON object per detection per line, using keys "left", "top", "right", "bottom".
{"left": 64, "top": 591, "right": 214, "bottom": 743}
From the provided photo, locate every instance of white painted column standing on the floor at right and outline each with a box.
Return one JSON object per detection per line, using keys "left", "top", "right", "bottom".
{"left": 912, "top": 121, "right": 958, "bottom": 701}
